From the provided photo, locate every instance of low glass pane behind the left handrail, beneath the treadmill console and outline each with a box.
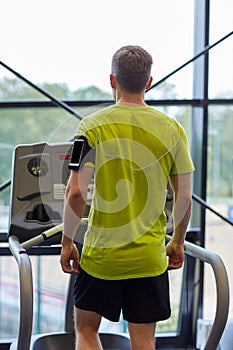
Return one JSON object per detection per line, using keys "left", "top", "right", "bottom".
{"left": 0, "top": 256, "right": 69, "bottom": 338}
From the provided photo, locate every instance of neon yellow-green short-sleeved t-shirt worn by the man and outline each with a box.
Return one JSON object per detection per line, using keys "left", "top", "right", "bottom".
{"left": 78, "top": 104, "right": 194, "bottom": 279}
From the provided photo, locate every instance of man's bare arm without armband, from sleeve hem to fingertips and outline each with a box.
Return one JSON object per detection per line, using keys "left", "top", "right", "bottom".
{"left": 166, "top": 173, "right": 192, "bottom": 269}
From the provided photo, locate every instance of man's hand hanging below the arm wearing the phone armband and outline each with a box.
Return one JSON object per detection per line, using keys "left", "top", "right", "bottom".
{"left": 60, "top": 240, "right": 80, "bottom": 274}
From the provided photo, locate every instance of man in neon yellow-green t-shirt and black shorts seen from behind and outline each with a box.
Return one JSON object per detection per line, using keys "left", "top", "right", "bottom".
{"left": 60, "top": 46, "right": 194, "bottom": 350}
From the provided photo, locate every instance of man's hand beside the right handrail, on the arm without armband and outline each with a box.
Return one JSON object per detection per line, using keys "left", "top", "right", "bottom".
{"left": 166, "top": 239, "right": 184, "bottom": 270}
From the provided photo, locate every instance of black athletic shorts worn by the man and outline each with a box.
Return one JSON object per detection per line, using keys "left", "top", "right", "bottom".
{"left": 74, "top": 270, "right": 171, "bottom": 323}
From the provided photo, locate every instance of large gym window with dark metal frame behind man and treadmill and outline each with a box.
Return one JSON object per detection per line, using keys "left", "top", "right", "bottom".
{"left": 0, "top": 0, "right": 233, "bottom": 348}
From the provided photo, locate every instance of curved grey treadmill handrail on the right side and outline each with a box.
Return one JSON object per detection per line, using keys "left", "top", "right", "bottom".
{"left": 166, "top": 235, "right": 230, "bottom": 350}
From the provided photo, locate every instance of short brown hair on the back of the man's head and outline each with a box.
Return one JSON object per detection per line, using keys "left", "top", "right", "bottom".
{"left": 112, "top": 45, "right": 153, "bottom": 93}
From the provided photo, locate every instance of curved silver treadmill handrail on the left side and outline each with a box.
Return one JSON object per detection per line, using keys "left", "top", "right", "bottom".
{"left": 9, "top": 235, "right": 33, "bottom": 350}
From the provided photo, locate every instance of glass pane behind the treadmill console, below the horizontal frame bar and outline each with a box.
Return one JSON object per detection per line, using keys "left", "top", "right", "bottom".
{"left": 0, "top": 108, "right": 81, "bottom": 232}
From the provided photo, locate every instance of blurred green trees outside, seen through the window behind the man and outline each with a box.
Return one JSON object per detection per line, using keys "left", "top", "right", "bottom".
{"left": 0, "top": 77, "right": 233, "bottom": 204}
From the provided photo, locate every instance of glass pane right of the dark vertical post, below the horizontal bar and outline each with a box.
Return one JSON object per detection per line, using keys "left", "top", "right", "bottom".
{"left": 204, "top": 106, "right": 233, "bottom": 319}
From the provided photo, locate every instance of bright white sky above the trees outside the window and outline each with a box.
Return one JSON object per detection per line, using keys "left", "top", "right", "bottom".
{"left": 0, "top": 0, "right": 233, "bottom": 97}
